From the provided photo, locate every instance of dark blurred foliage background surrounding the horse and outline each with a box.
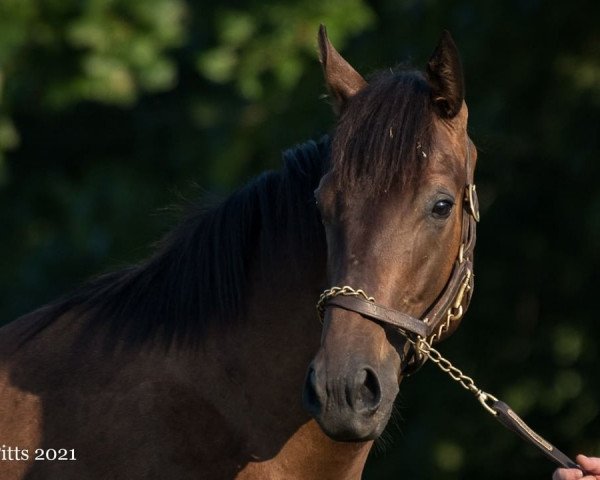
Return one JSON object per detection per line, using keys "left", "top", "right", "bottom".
{"left": 0, "top": 0, "right": 600, "bottom": 480}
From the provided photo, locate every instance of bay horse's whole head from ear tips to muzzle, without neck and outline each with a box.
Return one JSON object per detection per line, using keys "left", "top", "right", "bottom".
{"left": 303, "top": 27, "right": 478, "bottom": 441}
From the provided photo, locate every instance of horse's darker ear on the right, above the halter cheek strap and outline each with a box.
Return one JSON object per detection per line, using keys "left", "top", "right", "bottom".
{"left": 427, "top": 30, "right": 465, "bottom": 118}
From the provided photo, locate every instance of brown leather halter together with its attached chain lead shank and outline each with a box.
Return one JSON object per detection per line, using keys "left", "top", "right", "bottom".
{"left": 317, "top": 140, "right": 585, "bottom": 473}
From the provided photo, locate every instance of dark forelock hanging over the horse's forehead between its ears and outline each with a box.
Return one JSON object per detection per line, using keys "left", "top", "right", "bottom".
{"left": 331, "top": 69, "right": 434, "bottom": 195}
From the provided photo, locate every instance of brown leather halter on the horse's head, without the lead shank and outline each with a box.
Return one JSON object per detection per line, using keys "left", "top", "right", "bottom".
{"left": 317, "top": 140, "right": 479, "bottom": 375}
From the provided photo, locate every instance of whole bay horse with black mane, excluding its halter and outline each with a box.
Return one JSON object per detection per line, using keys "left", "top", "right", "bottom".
{"left": 0, "top": 27, "right": 476, "bottom": 480}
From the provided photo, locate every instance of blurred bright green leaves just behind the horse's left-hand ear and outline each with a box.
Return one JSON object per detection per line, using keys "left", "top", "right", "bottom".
{"left": 198, "top": 0, "right": 373, "bottom": 100}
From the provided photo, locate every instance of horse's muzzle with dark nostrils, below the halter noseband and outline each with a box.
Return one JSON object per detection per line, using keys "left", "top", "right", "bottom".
{"left": 302, "top": 309, "right": 400, "bottom": 442}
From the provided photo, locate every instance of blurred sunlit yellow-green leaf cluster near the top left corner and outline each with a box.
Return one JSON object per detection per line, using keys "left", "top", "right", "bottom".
{"left": 45, "top": 0, "right": 186, "bottom": 108}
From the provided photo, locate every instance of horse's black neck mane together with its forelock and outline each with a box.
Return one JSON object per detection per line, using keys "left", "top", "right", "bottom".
{"left": 17, "top": 66, "right": 432, "bottom": 345}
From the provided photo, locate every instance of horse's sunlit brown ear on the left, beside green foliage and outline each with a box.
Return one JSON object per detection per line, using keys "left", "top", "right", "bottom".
{"left": 319, "top": 25, "right": 367, "bottom": 114}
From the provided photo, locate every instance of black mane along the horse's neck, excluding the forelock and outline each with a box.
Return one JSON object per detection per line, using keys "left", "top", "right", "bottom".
{"left": 22, "top": 137, "right": 330, "bottom": 345}
